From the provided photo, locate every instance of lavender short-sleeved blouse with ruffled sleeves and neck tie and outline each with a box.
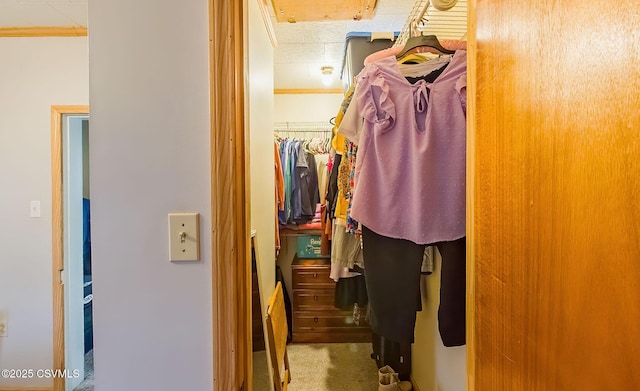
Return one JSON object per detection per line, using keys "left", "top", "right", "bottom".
{"left": 339, "top": 50, "right": 466, "bottom": 244}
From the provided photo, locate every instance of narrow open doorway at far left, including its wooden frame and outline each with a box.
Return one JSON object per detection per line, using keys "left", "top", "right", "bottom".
{"left": 52, "top": 106, "right": 93, "bottom": 391}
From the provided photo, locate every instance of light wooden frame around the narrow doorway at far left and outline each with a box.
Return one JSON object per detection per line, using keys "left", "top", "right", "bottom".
{"left": 51, "top": 106, "right": 89, "bottom": 391}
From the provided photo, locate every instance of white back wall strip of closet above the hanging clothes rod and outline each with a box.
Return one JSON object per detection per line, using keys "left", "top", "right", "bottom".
{"left": 273, "top": 94, "right": 344, "bottom": 122}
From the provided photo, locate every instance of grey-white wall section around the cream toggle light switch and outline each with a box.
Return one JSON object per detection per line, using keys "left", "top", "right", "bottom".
{"left": 89, "top": 0, "right": 213, "bottom": 391}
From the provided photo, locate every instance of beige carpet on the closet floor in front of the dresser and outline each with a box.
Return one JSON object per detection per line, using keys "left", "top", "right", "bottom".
{"left": 253, "top": 343, "right": 378, "bottom": 391}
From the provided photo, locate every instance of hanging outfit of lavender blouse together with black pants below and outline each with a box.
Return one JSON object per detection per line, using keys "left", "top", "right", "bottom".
{"left": 338, "top": 50, "right": 466, "bottom": 346}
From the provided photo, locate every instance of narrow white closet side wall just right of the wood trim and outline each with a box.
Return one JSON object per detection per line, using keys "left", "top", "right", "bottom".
{"left": 247, "top": 0, "right": 276, "bottom": 310}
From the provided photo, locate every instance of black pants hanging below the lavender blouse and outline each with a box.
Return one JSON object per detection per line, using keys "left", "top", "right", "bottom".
{"left": 362, "top": 227, "right": 466, "bottom": 346}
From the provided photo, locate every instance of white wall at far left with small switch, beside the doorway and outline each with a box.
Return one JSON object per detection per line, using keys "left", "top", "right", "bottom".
{"left": 0, "top": 37, "right": 89, "bottom": 387}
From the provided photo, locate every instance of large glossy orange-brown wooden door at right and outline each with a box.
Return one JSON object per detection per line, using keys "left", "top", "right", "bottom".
{"left": 468, "top": 0, "right": 640, "bottom": 391}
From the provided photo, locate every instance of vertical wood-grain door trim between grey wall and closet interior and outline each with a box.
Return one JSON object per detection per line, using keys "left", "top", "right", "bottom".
{"left": 209, "top": 0, "right": 252, "bottom": 391}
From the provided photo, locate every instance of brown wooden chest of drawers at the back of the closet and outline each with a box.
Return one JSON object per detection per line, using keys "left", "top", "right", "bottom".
{"left": 291, "top": 257, "right": 371, "bottom": 342}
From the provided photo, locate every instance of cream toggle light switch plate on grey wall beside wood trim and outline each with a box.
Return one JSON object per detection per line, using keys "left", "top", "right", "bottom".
{"left": 169, "top": 213, "right": 200, "bottom": 262}
